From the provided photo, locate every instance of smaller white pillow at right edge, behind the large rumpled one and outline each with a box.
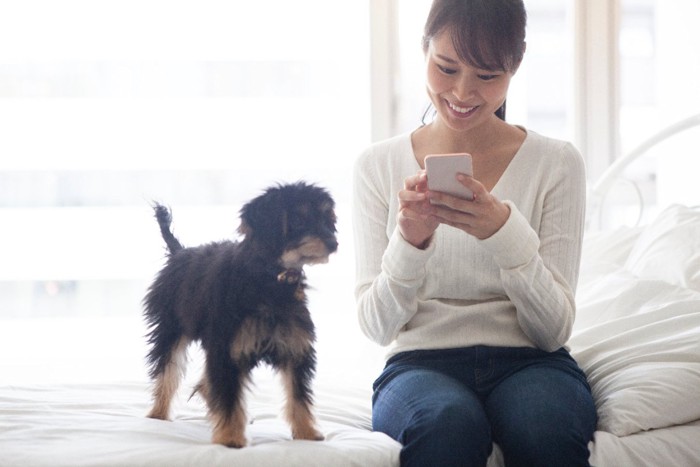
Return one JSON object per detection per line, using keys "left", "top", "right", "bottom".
{"left": 625, "top": 205, "right": 700, "bottom": 290}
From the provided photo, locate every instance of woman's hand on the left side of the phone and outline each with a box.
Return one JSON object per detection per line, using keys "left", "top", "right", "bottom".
{"left": 397, "top": 170, "right": 440, "bottom": 249}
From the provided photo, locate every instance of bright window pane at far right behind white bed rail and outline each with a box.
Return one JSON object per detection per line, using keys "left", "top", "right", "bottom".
{"left": 618, "top": 0, "right": 700, "bottom": 218}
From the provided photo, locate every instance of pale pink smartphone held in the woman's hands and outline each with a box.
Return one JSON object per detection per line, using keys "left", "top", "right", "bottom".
{"left": 425, "top": 153, "right": 474, "bottom": 202}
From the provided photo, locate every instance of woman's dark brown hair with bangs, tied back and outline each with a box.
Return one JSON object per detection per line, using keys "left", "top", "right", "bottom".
{"left": 423, "top": 0, "right": 527, "bottom": 120}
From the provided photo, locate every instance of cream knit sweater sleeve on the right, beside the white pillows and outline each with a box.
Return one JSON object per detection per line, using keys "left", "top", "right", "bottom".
{"left": 480, "top": 145, "right": 586, "bottom": 351}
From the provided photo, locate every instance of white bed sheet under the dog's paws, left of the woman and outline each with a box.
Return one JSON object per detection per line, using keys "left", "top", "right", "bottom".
{"left": 0, "top": 377, "right": 400, "bottom": 467}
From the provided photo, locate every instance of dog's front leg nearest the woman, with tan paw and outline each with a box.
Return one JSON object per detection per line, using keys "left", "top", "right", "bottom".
{"left": 282, "top": 354, "right": 323, "bottom": 441}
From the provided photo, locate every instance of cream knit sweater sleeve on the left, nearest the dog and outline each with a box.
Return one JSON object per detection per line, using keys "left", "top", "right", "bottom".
{"left": 353, "top": 148, "right": 434, "bottom": 345}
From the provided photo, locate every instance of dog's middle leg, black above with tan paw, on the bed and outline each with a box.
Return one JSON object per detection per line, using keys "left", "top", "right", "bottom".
{"left": 202, "top": 352, "right": 249, "bottom": 448}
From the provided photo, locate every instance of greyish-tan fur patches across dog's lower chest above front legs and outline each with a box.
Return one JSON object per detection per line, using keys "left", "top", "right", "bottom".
{"left": 230, "top": 313, "right": 313, "bottom": 361}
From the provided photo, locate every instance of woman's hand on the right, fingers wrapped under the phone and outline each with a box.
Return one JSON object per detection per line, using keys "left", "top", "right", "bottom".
{"left": 427, "top": 174, "right": 510, "bottom": 240}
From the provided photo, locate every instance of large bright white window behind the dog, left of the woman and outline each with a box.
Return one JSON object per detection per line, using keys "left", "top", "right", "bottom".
{"left": 0, "top": 0, "right": 369, "bottom": 381}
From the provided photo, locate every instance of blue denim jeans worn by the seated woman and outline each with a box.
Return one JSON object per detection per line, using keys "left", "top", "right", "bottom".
{"left": 372, "top": 346, "right": 596, "bottom": 467}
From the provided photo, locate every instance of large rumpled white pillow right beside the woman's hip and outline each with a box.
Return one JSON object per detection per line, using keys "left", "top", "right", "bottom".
{"left": 568, "top": 271, "right": 700, "bottom": 436}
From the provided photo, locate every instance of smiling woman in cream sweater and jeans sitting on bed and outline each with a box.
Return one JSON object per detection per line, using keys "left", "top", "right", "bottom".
{"left": 354, "top": 0, "right": 596, "bottom": 467}
